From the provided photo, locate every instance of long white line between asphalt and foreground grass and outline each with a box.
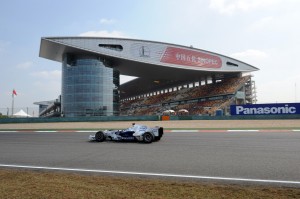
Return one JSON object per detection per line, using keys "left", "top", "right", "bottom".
{"left": 0, "top": 164, "right": 300, "bottom": 185}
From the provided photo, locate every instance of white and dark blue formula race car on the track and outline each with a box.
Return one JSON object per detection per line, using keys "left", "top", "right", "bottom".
{"left": 89, "top": 123, "right": 164, "bottom": 143}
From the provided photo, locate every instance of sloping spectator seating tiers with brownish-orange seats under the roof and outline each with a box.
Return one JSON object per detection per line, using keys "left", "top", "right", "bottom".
{"left": 121, "top": 76, "right": 256, "bottom": 115}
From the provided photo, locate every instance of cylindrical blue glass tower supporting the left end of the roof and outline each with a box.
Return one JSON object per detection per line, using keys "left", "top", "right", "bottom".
{"left": 61, "top": 53, "right": 120, "bottom": 117}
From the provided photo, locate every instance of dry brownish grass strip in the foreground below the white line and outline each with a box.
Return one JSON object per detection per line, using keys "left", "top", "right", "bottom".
{"left": 0, "top": 169, "right": 300, "bottom": 199}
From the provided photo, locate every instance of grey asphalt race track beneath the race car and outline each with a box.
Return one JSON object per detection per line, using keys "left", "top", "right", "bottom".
{"left": 0, "top": 131, "right": 300, "bottom": 187}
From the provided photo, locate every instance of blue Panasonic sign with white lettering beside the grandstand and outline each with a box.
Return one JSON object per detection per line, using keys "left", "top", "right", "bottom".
{"left": 230, "top": 103, "right": 300, "bottom": 115}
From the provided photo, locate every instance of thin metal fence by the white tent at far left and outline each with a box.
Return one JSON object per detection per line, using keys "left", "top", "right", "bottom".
{"left": 0, "top": 106, "right": 39, "bottom": 117}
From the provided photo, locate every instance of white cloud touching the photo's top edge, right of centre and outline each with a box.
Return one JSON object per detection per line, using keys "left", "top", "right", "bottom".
{"left": 209, "top": 0, "right": 279, "bottom": 14}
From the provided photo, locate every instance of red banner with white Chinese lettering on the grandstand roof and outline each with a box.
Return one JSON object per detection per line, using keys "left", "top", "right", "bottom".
{"left": 160, "top": 47, "right": 222, "bottom": 68}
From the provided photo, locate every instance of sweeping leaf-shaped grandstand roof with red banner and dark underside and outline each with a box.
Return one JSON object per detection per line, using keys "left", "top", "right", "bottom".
{"left": 39, "top": 37, "right": 258, "bottom": 97}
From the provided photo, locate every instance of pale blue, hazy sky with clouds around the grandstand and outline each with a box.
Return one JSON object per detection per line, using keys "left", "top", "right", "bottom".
{"left": 0, "top": 0, "right": 300, "bottom": 110}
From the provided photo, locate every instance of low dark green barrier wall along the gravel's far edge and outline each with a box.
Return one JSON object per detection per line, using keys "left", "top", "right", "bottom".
{"left": 0, "top": 114, "right": 300, "bottom": 124}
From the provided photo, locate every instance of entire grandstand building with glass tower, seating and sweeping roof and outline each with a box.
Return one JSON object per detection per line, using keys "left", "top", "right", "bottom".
{"left": 35, "top": 37, "right": 258, "bottom": 117}
